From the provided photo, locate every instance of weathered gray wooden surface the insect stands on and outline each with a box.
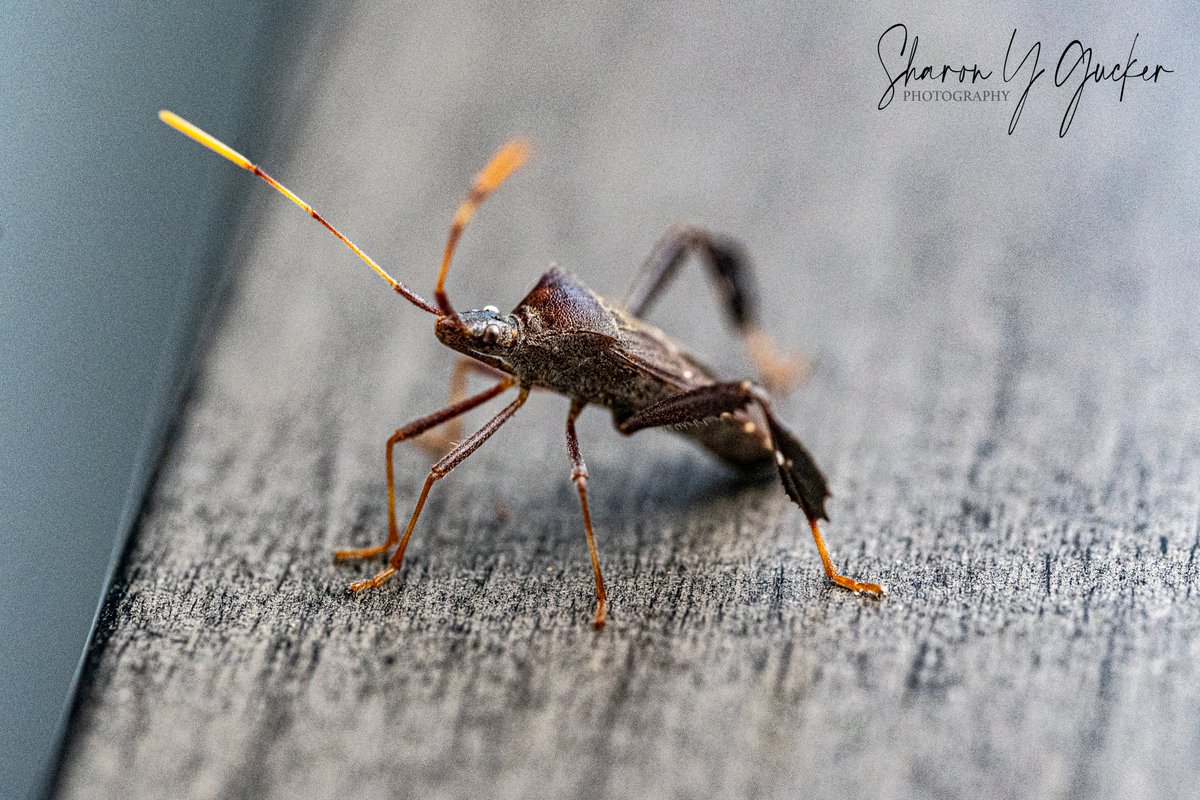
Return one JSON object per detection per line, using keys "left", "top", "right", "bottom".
{"left": 59, "top": 4, "right": 1200, "bottom": 798}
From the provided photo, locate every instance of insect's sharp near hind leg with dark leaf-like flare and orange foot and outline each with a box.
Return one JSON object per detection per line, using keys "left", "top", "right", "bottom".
{"left": 617, "top": 380, "right": 884, "bottom": 597}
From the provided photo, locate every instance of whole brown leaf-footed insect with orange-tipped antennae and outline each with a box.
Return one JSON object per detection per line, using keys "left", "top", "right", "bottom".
{"left": 158, "top": 112, "right": 884, "bottom": 627}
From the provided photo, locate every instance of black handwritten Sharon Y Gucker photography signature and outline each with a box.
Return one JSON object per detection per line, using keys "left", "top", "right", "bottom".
{"left": 875, "top": 23, "right": 1175, "bottom": 138}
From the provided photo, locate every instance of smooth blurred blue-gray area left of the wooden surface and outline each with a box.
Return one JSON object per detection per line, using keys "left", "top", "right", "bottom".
{"left": 0, "top": 1, "right": 305, "bottom": 798}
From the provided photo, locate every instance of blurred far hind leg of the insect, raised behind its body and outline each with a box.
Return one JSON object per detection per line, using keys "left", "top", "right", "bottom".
{"left": 625, "top": 225, "right": 809, "bottom": 393}
